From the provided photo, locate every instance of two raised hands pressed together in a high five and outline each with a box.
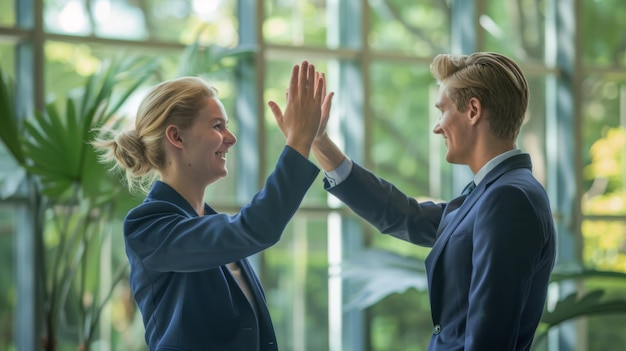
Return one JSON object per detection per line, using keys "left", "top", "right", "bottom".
{"left": 268, "top": 61, "right": 334, "bottom": 158}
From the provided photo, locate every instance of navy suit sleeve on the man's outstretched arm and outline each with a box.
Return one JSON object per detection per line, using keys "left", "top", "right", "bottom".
{"left": 326, "top": 163, "right": 445, "bottom": 247}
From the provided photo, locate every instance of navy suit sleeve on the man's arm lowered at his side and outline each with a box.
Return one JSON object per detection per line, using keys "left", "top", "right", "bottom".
{"left": 465, "top": 186, "right": 553, "bottom": 350}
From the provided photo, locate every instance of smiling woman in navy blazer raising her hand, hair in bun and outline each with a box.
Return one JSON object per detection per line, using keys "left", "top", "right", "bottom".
{"left": 94, "top": 61, "right": 331, "bottom": 351}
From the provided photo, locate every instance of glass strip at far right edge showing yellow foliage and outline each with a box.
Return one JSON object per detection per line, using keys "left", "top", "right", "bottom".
{"left": 579, "top": 0, "right": 626, "bottom": 350}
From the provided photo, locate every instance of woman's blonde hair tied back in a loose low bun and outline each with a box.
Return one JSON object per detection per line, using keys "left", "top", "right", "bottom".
{"left": 92, "top": 77, "right": 218, "bottom": 192}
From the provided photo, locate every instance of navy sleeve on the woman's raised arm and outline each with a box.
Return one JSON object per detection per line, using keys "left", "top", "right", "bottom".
{"left": 124, "top": 147, "right": 319, "bottom": 272}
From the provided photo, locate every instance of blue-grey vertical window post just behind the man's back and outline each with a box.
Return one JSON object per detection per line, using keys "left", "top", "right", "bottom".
{"left": 546, "top": 0, "right": 582, "bottom": 351}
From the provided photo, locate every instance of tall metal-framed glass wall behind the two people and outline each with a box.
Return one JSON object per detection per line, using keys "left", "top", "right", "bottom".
{"left": 0, "top": 0, "right": 626, "bottom": 351}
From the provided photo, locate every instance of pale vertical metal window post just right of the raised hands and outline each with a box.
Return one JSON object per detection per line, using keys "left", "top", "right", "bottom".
{"left": 327, "top": 0, "right": 369, "bottom": 351}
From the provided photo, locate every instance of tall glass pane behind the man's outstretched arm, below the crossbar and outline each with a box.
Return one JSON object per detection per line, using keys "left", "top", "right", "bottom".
{"left": 364, "top": 61, "right": 442, "bottom": 350}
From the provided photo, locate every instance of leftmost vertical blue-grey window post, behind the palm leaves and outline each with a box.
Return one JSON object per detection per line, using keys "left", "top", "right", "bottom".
{"left": 14, "top": 0, "right": 44, "bottom": 350}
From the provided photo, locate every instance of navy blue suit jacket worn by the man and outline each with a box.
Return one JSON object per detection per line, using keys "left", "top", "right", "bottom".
{"left": 328, "top": 154, "right": 555, "bottom": 351}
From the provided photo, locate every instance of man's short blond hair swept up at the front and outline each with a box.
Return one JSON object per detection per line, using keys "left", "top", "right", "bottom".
{"left": 430, "top": 52, "right": 529, "bottom": 140}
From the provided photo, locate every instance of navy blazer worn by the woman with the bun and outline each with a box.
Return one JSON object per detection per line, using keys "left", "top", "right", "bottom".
{"left": 124, "top": 147, "right": 319, "bottom": 351}
